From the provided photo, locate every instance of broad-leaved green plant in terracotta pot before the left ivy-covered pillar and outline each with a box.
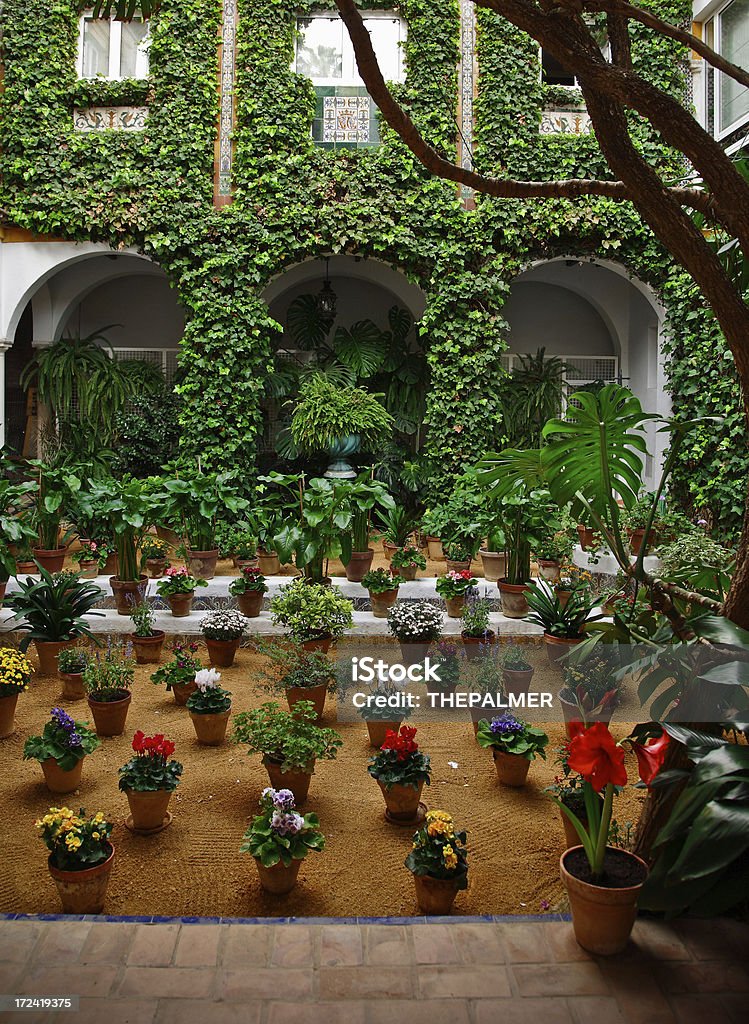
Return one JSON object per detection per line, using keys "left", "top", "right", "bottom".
{"left": 163, "top": 472, "right": 249, "bottom": 580}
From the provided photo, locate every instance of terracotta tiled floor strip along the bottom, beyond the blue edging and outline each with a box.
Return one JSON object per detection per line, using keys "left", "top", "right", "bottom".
{"left": 0, "top": 919, "right": 749, "bottom": 1024}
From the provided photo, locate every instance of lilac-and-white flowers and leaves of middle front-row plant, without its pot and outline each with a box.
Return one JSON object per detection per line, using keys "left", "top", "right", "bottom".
{"left": 240, "top": 786, "right": 325, "bottom": 867}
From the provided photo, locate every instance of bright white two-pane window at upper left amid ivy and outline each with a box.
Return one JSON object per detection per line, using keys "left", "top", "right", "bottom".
{"left": 78, "top": 15, "right": 149, "bottom": 79}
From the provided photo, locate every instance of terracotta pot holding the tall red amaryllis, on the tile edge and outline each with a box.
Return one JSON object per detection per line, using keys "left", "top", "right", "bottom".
{"left": 559, "top": 846, "right": 648, "bottom": 956}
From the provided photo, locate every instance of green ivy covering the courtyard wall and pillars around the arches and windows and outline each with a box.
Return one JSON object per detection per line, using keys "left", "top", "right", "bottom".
{"left": 0, "top": 0, "right": 749, "bottom": 540}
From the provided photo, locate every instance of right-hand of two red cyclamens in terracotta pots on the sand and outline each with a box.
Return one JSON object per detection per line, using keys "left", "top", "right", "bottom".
{"left": 367, "top": 725, "right": 431, "bottom": 825}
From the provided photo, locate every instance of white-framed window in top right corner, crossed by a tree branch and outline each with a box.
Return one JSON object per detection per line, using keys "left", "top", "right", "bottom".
{"left": 704, "top": 0, "right": 749, "bottom": 138}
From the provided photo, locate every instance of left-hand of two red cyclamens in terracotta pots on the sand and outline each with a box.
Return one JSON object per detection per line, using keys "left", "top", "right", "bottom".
{"left": 120, "top": 729, "right": 182, "bottom": 835}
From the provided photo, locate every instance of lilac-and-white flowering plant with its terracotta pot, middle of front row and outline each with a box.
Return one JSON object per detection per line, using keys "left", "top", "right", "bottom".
{"left": 240, "top": 786, "right": 325, "bottom": 896}
